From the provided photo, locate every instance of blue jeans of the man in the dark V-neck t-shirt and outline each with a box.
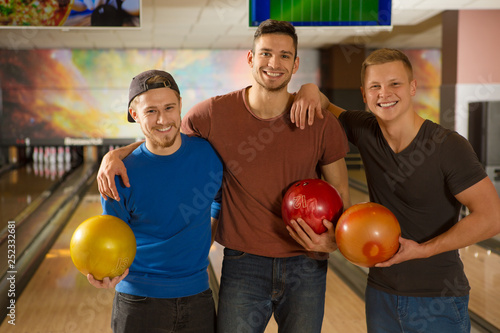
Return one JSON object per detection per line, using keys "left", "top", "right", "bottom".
{"left": 365, "top": 286, "right": 471, "bottom": 333}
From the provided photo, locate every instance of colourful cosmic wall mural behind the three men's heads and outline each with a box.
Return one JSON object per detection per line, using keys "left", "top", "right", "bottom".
{"left": 0, "top": 49, "right": 441, "bottom": 145}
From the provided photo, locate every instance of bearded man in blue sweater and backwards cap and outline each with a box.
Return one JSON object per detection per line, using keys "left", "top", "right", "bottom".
{"left": 88, "top": 70, "right": 222, "bottom": 333}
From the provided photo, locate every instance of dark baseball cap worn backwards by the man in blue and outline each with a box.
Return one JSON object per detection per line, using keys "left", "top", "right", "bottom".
{"left": 127, "top": 69, "right": 181, "bottom": 123}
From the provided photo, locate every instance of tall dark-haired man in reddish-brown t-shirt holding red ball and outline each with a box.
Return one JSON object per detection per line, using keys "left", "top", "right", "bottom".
{"left": 99, "top": 20, "right": 350, "bottom": 333}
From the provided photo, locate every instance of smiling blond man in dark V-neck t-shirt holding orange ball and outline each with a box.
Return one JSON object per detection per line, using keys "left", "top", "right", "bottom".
{"left": 290, "top": 49, "right": 500, "bottom": 333}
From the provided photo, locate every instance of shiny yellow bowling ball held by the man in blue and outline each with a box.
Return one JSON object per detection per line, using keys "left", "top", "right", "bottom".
{"left": 70, "top": 215, "right": 137, "bottom": 280}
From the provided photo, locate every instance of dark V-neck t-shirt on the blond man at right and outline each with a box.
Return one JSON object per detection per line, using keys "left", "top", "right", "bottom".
{"left": 339, "top": 111, "right": 487, "bottom": 297}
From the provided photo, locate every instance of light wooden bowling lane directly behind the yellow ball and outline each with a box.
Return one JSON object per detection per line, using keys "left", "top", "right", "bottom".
{"left": 0, "top": 182, "right": 114, "bottom": 333}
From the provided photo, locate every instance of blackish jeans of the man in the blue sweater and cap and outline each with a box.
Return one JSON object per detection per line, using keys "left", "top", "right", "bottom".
{"left": 111, "top": 289, "right": 215, "bottom": 333}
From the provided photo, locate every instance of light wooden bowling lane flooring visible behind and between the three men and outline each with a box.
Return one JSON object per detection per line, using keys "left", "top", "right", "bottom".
{"left": 0, "top": 171, "right": 500, "bottom": 333}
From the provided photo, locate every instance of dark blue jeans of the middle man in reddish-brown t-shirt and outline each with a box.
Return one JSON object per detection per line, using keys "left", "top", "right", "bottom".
{"left": 217, "top": 248, "right": 328, "bottom": 333}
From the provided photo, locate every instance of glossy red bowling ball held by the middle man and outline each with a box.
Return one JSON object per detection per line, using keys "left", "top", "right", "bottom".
{"left": 281, "top": 179, "right": 344, "bottom": 234}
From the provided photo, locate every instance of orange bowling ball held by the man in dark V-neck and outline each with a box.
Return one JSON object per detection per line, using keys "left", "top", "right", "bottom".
{"left": 335, "top": 202, "right": 401, "bottom": 267}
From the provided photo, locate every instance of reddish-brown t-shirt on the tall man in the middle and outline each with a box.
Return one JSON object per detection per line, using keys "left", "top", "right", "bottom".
{"left": 182, "top": 89, "right": 348, "bottom": 257}
